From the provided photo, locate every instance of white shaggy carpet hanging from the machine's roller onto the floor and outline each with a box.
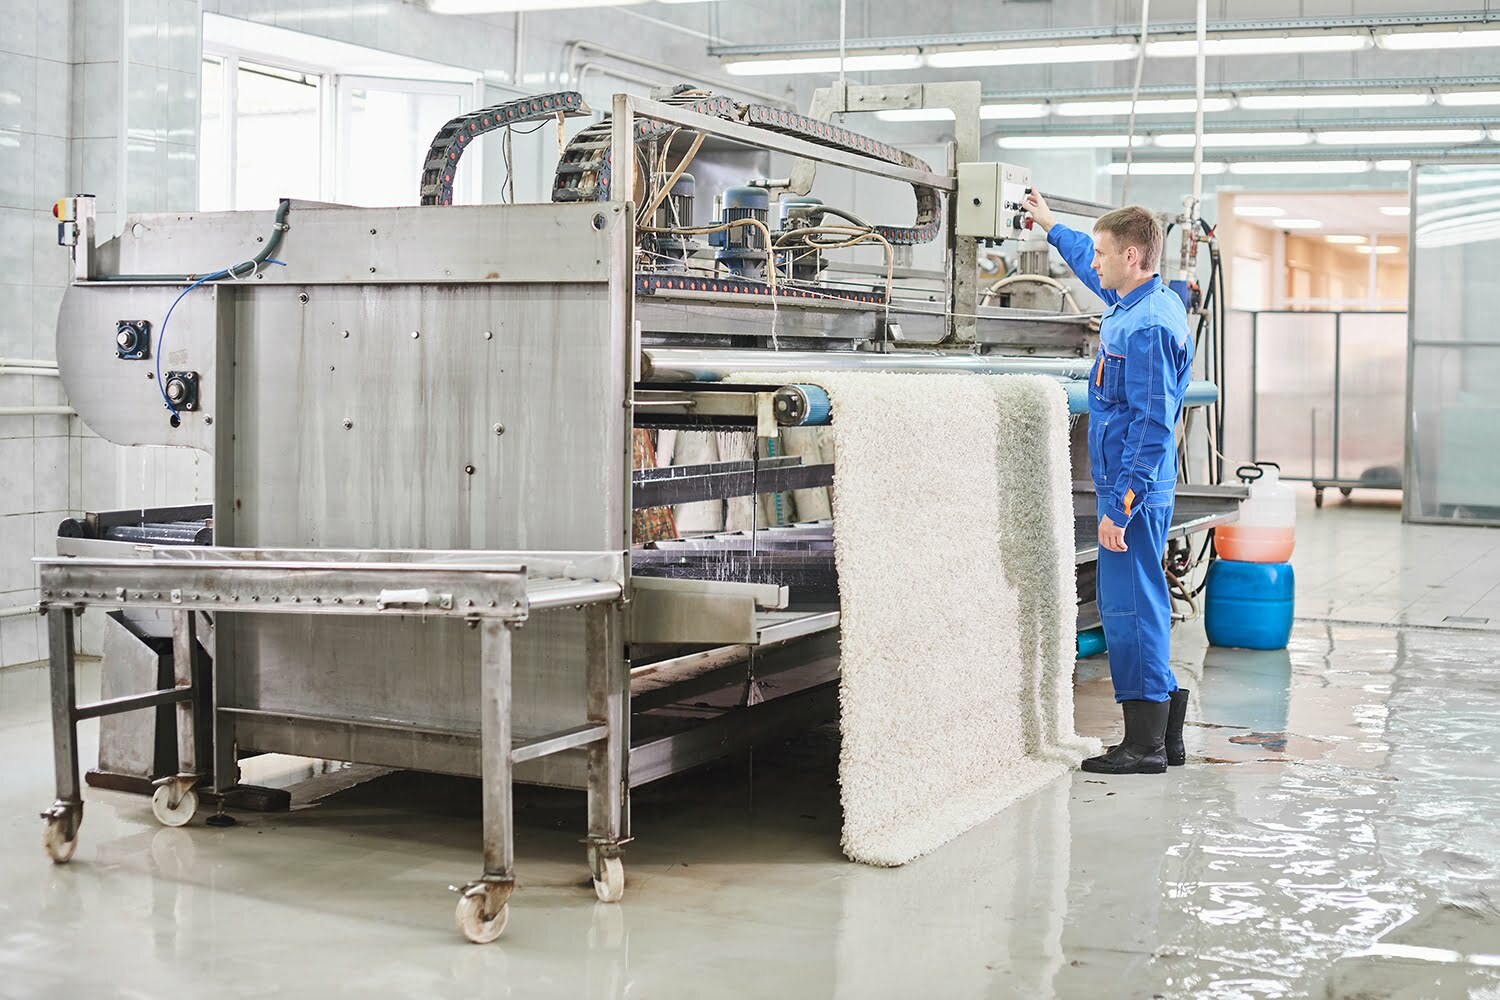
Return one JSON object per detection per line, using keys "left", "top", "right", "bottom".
{"left": 738, "top": 372, "right": 1100, "bottom": 865}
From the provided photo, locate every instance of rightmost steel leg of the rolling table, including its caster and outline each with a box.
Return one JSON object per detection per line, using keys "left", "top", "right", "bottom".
{"left": 584, "top": 604, "right": 630, "bottom": 903}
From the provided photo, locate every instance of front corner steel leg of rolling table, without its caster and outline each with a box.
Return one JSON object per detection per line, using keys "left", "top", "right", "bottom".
{"left": 479, "top": 618, "right": 516, "bottom": 879}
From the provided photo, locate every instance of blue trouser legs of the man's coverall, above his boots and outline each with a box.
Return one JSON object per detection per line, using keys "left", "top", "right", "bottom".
{"left": 1098, "top": 493, "right": 1178, "bottom": 702}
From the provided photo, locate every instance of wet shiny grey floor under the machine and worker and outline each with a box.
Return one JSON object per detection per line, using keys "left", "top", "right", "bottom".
{"left": 0, "top": 497, "right": 1500, "bottom": 1000}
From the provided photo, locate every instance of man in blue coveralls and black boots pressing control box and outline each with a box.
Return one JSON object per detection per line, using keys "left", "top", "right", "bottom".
{"left": 1026, "top": 190, "right": 1193, "bottom": 774}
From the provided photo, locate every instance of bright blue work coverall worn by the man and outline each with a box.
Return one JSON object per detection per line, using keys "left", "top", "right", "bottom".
{"left": 1047, "top": 225, "right": 1193, "bottom": 702}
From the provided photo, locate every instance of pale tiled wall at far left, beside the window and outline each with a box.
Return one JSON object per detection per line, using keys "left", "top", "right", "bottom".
{"left": 0, "top": 0, "right": 199, "bottom": 666}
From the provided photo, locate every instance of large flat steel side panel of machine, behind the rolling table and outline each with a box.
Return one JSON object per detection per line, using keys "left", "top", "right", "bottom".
{"left": 221, "top": 218, "right": 632, "bottom": 786}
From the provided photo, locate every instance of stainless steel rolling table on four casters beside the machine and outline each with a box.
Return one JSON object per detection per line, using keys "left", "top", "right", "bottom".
{"left": 39, "top": 549, "right": 624, "bottom": 943}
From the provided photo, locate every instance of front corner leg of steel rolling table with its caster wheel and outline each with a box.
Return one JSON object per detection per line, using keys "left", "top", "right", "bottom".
{"left": 455, "top": 619, "right": 516, "bottom": 945}
